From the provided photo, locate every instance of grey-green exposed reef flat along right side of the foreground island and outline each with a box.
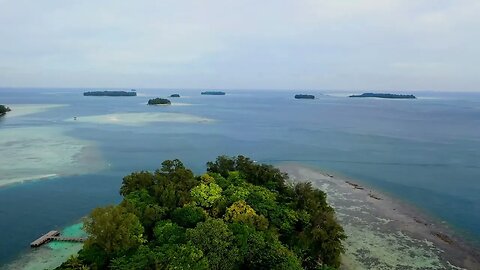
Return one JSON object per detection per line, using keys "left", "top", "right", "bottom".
{"left": 276, "top": 163, "right": 480, "bottom": 269}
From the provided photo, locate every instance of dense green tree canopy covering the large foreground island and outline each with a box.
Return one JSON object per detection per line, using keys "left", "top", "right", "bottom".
{"left": 57, "top": 156, "right": 345, "bottom": 270}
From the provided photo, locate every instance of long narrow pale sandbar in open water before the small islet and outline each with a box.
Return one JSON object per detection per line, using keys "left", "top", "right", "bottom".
{"left": 66, "top": 112, "right": 214, "bottom": 126}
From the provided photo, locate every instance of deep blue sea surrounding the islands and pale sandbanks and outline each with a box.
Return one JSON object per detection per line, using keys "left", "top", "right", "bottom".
{"left": 0, "top": 89, "right": 480, "bottom": 265}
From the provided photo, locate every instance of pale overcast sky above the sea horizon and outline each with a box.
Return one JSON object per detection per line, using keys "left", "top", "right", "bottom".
{"left": 0, "top": 0, "right": 480, "bottom": 92}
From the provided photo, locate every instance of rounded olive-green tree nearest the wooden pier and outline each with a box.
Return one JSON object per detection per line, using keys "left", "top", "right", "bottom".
{"left": 83, "top": 206, "right": 144, "bottom": 256}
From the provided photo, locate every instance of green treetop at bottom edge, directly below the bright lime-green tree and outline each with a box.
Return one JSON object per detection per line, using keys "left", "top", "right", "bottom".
{"left": 187, "top": 219, "right": 242, "bottom": 269}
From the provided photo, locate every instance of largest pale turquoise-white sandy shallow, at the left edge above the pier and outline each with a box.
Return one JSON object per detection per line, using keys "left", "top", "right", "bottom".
{"left": 0, "top": 127, "right": 105, "bottom": 187}
